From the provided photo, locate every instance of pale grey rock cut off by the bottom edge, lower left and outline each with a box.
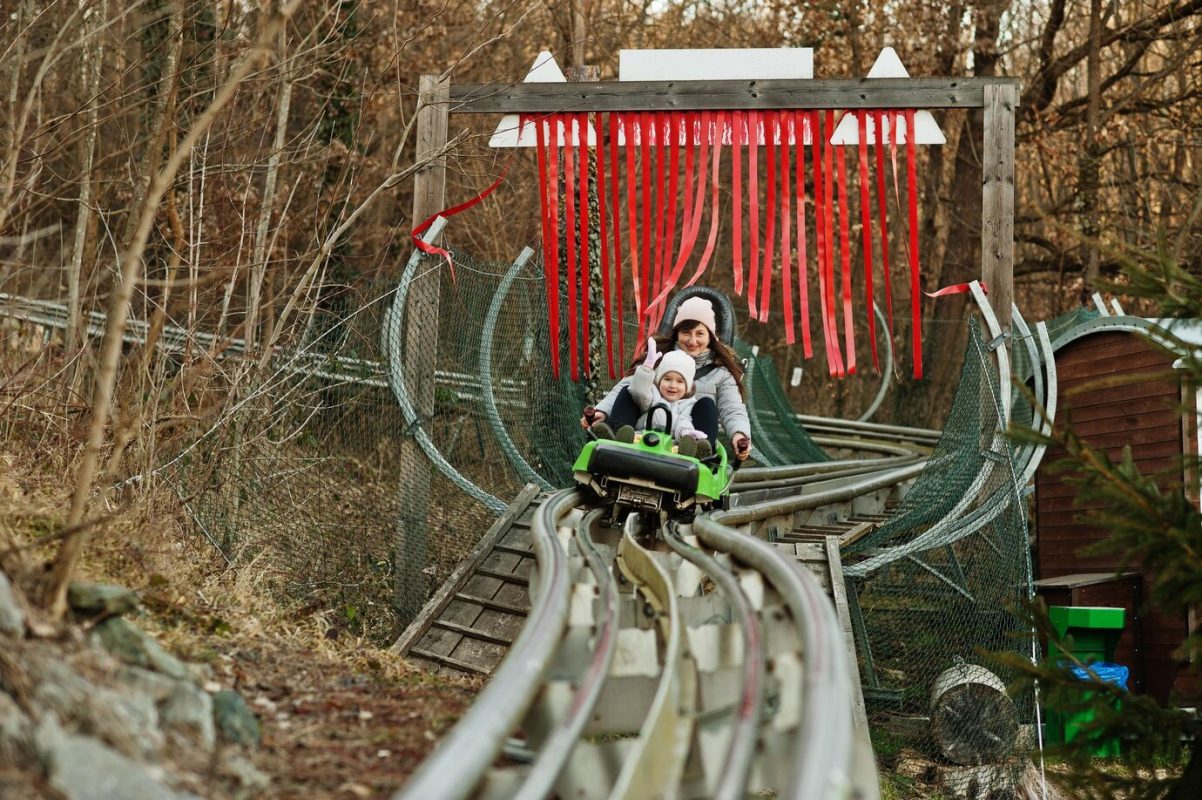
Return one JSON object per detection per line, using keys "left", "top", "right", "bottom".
{"left": 38, "top": 717, "right": 179, "bottom": 800}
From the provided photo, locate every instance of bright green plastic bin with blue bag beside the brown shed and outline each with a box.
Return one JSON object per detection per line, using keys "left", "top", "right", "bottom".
{"left": 1045, "top": 605, "right": 1126, "bottom": 758}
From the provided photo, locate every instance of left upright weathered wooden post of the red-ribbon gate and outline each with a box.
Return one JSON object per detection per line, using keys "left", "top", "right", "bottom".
{"left": 393, "top": 74, "right": 451, "bottom": 623}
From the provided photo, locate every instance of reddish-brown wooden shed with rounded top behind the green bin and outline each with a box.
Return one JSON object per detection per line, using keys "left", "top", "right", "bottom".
{"left": 1035, "top": 317, "right": 1202, "bottom": 702}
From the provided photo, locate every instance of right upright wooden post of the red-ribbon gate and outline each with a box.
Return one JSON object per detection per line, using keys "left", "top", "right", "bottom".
{"left": 981, "top": 84, "right": 1018, "bottom": 330}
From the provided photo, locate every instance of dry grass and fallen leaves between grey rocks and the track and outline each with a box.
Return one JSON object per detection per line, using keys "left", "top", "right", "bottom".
{"left": 0, "top": 436, "right": 478, "bottom": 798}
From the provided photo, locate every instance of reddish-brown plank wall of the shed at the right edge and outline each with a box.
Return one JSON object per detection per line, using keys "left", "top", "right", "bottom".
{"left": 1035, "top": 332, "right": 1196, "bottom": 700}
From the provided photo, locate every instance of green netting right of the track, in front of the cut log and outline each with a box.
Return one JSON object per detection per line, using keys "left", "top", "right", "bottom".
{"left": 844, "top": 320, "right": 1034, "bottom": 787}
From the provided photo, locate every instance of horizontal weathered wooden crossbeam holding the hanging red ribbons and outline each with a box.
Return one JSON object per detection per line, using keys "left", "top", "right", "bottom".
{"left": 451, "top": 78, "right": 1018, "bottom": 114}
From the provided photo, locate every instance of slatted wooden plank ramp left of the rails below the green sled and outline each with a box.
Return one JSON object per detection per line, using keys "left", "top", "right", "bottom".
{"left": 389, "top": 484, "right": 543, "bottom": 675}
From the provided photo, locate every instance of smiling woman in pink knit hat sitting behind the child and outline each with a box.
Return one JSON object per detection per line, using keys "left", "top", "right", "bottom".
{"left": 581, "top": 297, "right": 751, "bottom": 461}
